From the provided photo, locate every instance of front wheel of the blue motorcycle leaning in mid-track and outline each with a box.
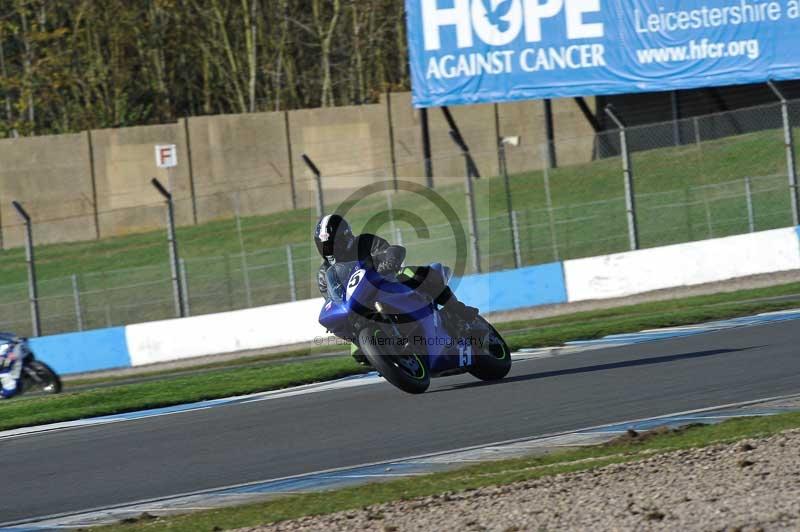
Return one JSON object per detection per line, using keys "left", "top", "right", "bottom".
{"left": 358, "top": 328, "right": 431, "bottom": 394}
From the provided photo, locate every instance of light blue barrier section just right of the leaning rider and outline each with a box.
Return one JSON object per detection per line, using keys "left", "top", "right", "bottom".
{"left": 453, "top": 262, "right": 567, "bottom": 312}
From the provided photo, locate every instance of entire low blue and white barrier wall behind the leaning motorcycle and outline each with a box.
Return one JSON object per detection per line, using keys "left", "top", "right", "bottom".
{"left": 25, "top": 228, "right": 800, "bottom": 374}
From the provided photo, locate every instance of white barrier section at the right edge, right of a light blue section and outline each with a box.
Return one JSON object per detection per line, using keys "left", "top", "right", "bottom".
{"left": 564, "top": 228, "right": 800, "bottom": 302}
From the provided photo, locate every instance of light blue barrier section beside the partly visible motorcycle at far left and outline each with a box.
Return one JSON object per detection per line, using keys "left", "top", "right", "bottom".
{"left": 31, "top": 327, "right": 131, "bottom": 375}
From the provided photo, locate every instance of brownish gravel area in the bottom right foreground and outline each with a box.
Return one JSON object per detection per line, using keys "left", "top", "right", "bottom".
{"left": 242, "top": 430, "right": 800, "bottom": 532}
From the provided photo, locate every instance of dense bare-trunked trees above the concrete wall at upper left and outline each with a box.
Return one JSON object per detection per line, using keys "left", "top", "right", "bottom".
{"left": 0, "top": 0, "right": 408, "bottom": 136}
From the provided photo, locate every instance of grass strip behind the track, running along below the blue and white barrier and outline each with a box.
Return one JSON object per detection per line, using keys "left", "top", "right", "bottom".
{"left": 6, "top": 283, "right": 800, "bottom": 430}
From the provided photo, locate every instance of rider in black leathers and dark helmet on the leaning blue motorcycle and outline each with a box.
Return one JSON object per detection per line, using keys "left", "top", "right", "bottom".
{"left": 314, "top": 214, "right": 478, "bottom": 322}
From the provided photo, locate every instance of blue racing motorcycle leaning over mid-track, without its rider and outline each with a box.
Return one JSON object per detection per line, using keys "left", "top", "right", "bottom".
{"left": 319, "top": 261, "right": 511, "bottom": 394}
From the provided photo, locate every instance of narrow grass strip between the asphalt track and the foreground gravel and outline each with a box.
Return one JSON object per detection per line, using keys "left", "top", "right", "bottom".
{"left": 97, "top": 413, "right": 800, "bottom": 532}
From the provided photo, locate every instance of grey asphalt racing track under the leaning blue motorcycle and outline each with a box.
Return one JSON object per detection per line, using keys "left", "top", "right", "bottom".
{"left": 0, "top": 321, "right": 800, "bottom": 522}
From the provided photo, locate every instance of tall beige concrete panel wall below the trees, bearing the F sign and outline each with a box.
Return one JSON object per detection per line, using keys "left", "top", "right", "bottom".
{"left": 0, "top": 93, "right": 593, "bottom": 247}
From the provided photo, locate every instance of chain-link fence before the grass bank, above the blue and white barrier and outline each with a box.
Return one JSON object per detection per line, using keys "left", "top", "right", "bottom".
{"left": 0, "top": 98, "right": 800, "bottom": 334}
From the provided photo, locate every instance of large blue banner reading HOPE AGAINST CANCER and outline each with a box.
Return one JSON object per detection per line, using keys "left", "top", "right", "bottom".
{"left": 406, "top": 0, "right": 800, "bottom": 107}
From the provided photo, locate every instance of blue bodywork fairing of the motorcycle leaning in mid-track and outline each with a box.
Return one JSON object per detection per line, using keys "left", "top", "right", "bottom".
{"left": 319, "top": 262, "right": 467, "bottom": 375}
